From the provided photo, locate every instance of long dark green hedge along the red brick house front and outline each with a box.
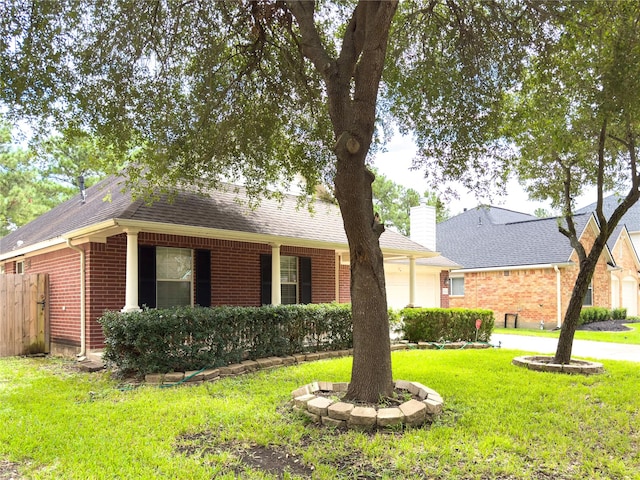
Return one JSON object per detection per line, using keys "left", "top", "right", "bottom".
{"left": 98, "top": 304, "right": 353, "bottom": 375}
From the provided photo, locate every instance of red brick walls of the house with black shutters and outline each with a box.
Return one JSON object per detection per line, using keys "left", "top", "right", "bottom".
{"left": 15, "top": 233, "right": 340, "bottom": 353}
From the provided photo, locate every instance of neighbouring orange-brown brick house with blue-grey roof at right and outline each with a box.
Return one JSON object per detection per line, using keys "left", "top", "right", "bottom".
{"left": 437, "top": 206, "right": 640, "bottom": 329}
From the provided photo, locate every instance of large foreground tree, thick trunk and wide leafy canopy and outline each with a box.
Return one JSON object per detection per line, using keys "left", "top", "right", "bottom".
{"left": 0, "top": 0, "right": 553, "bottom": 402}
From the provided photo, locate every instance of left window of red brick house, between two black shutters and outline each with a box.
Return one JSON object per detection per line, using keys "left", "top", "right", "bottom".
{"left": 156, "top": 247, "right": 193, "bottom": 308}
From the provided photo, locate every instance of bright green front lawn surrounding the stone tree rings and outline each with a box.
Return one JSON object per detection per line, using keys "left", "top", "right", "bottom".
{"left": 0, "top": 349, "right": 640, "bottom": 480}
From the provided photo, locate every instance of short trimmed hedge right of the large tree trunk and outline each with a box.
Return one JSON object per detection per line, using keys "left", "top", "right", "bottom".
{"left": 401, "top": 308, "right": 494, "bottom": 342}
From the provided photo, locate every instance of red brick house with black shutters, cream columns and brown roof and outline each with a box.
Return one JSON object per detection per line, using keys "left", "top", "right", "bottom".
{"left": 0, "top": 177, "right": 450, "bottom": 354}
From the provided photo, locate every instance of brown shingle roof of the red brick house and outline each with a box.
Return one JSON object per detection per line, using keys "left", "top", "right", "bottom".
{"left": 0, "top": 177, "right": 430, "bottom": 254}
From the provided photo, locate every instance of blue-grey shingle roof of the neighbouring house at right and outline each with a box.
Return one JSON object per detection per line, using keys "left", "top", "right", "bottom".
{"left": 436, "top": 207, "right": 590, "bottom": 269}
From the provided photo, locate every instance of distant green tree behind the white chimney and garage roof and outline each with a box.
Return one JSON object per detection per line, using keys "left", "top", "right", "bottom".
{"left": 372, "top": 169, "right": 449, "bottom": 236}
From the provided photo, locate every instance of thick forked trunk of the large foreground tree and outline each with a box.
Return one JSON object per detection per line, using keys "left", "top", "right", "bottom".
{"left": 287, "top": 0, "right": 398, "bottom": 402}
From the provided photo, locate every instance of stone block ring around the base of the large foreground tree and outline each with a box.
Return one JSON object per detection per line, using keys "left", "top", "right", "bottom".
{"left": 291, "top": 380, "right": 444, "bottom": 430}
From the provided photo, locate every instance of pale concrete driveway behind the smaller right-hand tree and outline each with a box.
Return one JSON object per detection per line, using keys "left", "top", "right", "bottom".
{"left": 490, "top": 333, "right": 640, "bottom": 362}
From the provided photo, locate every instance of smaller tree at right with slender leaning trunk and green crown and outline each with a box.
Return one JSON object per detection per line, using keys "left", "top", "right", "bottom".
{"left": 504, "top": 1, "right": 640, "bottom": 363}
